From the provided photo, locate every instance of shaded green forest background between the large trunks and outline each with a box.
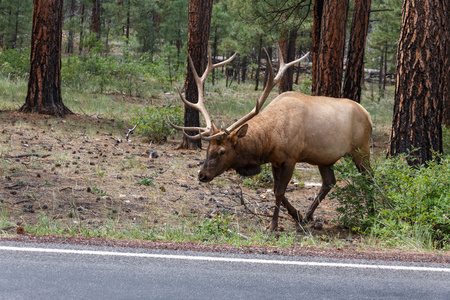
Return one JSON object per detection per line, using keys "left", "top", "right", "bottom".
{"left": 0, "top": 0, "right": 402, "bottom": 94}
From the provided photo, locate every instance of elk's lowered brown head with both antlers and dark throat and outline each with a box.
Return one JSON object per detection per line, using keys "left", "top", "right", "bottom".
{"left": 168, "top": 45, "right": 309, "bottom": 182}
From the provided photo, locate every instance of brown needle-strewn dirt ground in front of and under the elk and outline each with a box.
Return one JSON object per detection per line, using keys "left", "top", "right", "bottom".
{"left": 0, "top": 111, "right": 386, "bottom": 239}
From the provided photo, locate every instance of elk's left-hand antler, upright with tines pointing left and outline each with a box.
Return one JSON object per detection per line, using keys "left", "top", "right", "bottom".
{"left": 168, "top": 44, "right": 236, "bottom": 139}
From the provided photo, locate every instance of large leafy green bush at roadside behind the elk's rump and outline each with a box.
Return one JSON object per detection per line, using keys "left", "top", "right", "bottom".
{"left": 330, "top": 156, "right": 450, "bottom": 248}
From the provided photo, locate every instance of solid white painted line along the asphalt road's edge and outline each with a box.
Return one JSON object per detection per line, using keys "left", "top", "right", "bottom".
{"left": 0, "top": 246, "right": 450, "bottom": 273}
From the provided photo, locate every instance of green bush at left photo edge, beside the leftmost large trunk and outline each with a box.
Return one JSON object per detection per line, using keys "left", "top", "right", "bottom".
{"left": 0, "top": 48, "right": 30, "bottom": 79}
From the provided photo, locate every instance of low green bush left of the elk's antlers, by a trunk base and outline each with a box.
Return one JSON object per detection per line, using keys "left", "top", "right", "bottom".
{"left": 132, "top": 106, "right": 184, "bottom": 143}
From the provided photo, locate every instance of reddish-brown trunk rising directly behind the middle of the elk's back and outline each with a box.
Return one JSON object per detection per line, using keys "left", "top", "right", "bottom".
{"left": 313, "top": 0, "right": 349, "bottom": 98}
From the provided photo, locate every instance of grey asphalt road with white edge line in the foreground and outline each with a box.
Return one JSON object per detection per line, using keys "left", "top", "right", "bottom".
{"left": 0, "top": 241, "right": 450, "bottom": 300}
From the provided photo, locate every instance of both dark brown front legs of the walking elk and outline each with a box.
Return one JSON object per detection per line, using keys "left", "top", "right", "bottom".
{"left": 270, "top": 162, "right": 302, "bottom": 230}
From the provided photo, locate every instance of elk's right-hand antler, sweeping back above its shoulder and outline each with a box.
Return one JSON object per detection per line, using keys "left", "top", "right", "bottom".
{"left": 224, "top": 44, "right": 309, "bottom": 138}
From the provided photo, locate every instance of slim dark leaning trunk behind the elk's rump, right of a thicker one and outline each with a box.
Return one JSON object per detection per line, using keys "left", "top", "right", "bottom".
{"left": 342, "top": 0, "right": 371, "bottom": 103}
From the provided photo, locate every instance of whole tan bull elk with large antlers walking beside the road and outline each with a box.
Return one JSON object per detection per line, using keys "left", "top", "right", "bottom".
{"left": 169, "top": 47, "right": 372, "bottom": 230}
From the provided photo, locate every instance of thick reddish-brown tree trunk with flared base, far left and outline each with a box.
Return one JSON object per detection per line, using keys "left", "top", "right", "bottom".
{"left": 20, "top": 0, "right": 72, "bottom": 117}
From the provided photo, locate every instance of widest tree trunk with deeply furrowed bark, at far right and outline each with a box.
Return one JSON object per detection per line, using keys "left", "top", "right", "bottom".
{"left": 388, "top": 0, "right": 448, "bottom": 165}
